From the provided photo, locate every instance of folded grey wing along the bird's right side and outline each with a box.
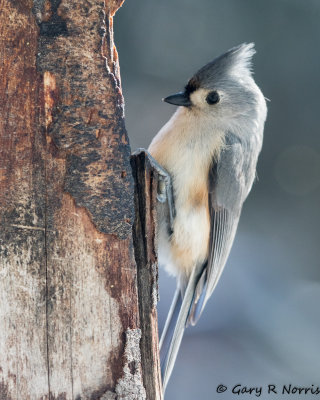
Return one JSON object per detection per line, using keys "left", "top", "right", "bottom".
{"left": 188, "top": 133, "right": 262, "bottom": 325}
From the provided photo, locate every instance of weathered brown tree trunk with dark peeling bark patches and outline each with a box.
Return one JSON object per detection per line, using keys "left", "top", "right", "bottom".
{"left": 0, "top": 0, "right": 161, "bottom": 400}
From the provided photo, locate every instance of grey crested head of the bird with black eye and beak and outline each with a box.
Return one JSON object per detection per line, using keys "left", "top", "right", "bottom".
{"left": 163, "top": 43, "right": 264, "bottom": 126}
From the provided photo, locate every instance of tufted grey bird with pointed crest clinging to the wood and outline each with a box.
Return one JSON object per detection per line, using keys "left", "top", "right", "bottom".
{"left": 148, "top": 43, "right": 267, "bottom": 390}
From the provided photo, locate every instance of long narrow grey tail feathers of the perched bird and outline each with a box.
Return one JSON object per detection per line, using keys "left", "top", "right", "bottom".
{"left": 160, "top": 269, "right": 199, "bottom": 392}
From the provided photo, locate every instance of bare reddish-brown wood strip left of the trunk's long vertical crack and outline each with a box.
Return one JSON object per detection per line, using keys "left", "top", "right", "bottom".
{"left": 0, "top": 1, "right": 49, "bottom": 400}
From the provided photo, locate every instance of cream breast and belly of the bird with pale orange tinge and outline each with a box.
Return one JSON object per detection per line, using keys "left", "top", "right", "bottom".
{"left": 149, "top": 108, "right": 223, "bottom": 276}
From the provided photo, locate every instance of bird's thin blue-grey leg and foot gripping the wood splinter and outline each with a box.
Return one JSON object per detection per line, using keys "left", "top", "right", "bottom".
{"left": 134, "top": 149, "right": 176, "bottom": 232}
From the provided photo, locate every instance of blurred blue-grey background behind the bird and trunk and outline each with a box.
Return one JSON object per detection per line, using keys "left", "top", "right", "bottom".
{"left": 115, "top": 0, "right": 320, "bottom": 400}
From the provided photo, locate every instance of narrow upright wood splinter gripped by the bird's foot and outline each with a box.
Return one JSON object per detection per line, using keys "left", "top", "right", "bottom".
{"left": 131, "top": 151, "right": 162, "bottom": 400}
